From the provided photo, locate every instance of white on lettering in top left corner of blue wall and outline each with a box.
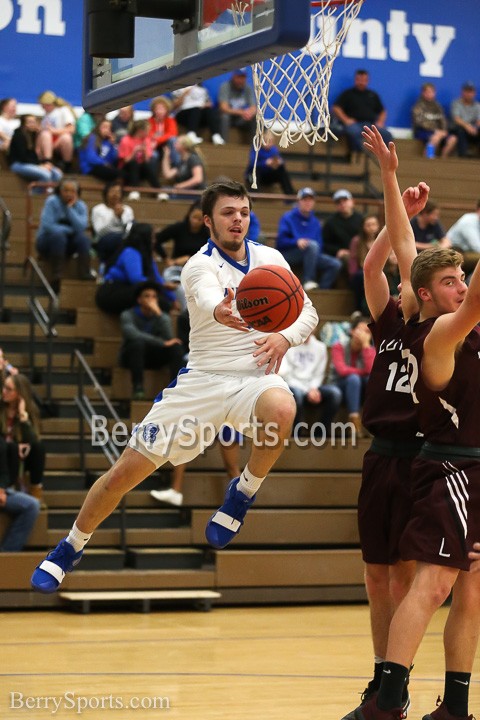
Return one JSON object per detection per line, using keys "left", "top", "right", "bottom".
{"left": 0, "top": 0, "right": 65, "bottom": 35}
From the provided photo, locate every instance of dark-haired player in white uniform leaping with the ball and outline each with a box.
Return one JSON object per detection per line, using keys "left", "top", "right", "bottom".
{"left": 32, "top": 181, "right": 318, "bottom": 593}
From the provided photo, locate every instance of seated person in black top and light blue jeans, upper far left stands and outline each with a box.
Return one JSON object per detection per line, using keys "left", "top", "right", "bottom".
{"left": 8, "top": 115, "right": 62, "bottom": 182}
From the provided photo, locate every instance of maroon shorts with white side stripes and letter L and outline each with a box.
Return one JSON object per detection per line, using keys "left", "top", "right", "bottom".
{"left": 400, "top": 457, "right": 480, "bottom": 570}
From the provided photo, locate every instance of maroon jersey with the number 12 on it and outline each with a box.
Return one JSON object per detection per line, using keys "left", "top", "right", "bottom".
{"left": 362, "top": 298, "right": 418, "bottom": 441}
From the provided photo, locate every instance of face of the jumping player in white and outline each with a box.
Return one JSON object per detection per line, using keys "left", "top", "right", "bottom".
{"left": 204, "top": 195, "right": 250, "bottom": 260}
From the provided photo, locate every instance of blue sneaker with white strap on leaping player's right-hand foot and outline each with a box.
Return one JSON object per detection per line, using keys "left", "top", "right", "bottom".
{"left": 205, "top": 478, "right": 257, "bottom": 550}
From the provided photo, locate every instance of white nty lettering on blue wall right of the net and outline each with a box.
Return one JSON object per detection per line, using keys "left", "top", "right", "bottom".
{"left": 313, "top": 10, "right": 456, "bottom": 77}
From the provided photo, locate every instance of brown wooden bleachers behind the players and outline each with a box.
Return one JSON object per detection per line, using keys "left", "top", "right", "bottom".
{"left": 0, "top": 131, "right": 478, "bottom": 607}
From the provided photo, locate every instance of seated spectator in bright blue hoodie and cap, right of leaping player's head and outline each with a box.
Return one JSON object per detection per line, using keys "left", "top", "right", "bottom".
{"left": 277, "top": 187, "right": 342, "bottom": 291}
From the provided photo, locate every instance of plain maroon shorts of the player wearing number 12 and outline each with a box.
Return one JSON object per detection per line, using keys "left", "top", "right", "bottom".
{"left": 358, "top": 450, "right": 413, "bottom": 565}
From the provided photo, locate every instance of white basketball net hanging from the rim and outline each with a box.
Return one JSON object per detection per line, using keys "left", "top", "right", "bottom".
{"left": 252, "top": 0, "right": 364, "bottom": 189}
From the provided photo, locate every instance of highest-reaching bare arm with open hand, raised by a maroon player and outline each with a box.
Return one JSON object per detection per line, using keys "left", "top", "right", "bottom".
{"left": 362, "top": 126, "right": 426, "bottom": 319}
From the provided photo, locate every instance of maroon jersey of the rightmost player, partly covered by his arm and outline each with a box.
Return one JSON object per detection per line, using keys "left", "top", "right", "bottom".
{"left": 403, "top": 318, "right": 480, "bottom": 447}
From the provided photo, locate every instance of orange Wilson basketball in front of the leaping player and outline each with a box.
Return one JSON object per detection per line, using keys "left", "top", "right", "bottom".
{"left": 236, "top": 265, "right": 304, "bottom": 332}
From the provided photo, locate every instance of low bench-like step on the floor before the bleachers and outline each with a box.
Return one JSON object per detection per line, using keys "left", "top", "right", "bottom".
{"left": 59, "top": 590, "right": 222, "bottom": 614}
